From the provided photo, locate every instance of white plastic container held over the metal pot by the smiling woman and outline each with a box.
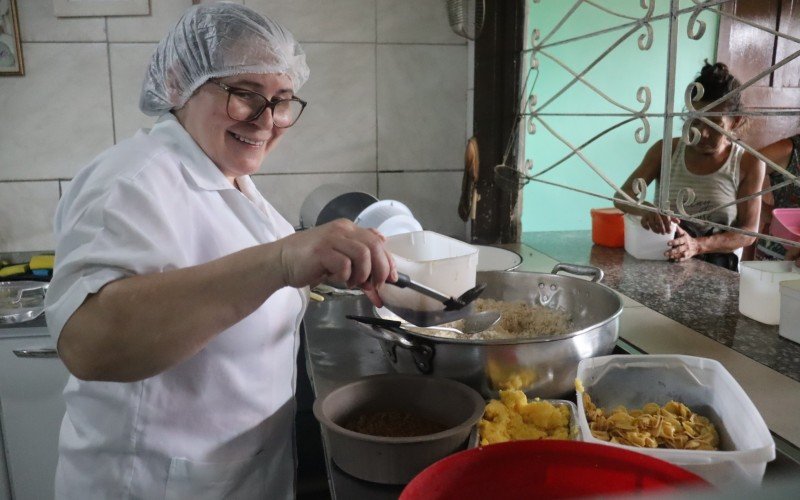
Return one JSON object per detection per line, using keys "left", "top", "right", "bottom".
{"left": 379, "top": 231, "right": 478, "bottom": 324}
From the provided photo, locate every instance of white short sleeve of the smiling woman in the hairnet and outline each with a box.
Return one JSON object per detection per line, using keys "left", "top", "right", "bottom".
{"left": 45, "top": 174, "right": 184, "bottom": 341}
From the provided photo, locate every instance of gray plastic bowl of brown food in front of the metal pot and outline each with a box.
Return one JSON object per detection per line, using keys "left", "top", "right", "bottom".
{"left": 314, "top": 374, "right": 486, "bottom": 484}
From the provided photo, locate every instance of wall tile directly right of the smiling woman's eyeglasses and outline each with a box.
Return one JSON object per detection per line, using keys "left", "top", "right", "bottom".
{"left": 263, "top": 43, "right": 376, "bottom": 173}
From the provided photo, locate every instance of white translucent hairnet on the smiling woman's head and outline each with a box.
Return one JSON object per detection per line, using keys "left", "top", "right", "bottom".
{"left": 139, "top": 2, "right": 309, "bottom": 116}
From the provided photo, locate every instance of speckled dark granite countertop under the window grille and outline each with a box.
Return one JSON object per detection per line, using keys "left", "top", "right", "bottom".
{"left": 522, "top": 231, "right": 800, "bottom": 382}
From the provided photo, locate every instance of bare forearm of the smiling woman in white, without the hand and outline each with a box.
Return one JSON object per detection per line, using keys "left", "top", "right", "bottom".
{"left": 58, "top": 243, "right": 285, "bottom": 382}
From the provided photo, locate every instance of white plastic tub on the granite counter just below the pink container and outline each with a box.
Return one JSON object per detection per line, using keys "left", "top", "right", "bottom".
{"left": 739, "top": 261, "right": 800, "bottom": 325}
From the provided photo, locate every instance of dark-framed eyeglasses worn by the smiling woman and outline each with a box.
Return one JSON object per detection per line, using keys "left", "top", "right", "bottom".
{"left": 209, "top": 80, "right": 308, "bottom": 128}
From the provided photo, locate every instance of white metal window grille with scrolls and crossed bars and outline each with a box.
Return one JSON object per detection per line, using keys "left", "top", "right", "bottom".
{"left": 512, "top": 0, "right": 800, "bottom": 250}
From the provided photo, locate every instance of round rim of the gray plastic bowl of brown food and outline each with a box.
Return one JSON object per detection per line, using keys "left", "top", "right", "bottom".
{"left": 312, "top": 374, "right": 486, "bottom": 444}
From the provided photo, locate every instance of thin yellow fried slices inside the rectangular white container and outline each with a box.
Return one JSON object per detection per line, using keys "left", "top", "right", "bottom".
{"left": 576, "top": 390, "right": 719, "bottom": 450}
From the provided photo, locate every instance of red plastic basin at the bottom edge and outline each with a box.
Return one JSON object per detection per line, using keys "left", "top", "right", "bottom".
{"left": 400, "top": 441, "right": 708, "bottom": 500}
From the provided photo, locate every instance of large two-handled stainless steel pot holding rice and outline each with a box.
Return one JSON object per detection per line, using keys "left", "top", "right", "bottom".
{"left": 359, "top": 264, "right": 622, "bottom": 398}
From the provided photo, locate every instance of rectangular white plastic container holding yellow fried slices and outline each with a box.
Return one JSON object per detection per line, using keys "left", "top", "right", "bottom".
{"left": 577, "top": 354, "right": 775, "bottom": 487}
